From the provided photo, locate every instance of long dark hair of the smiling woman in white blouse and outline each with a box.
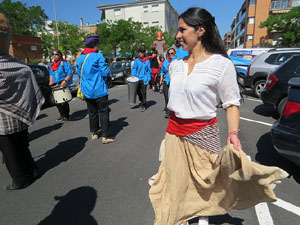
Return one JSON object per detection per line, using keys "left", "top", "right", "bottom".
{"left": 179, "top": 7, "right": 228, "bottom": 58}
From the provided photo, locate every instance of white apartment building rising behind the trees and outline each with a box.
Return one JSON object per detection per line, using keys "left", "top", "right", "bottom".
{"left": 97, "top": 0, "right": 178, "bottom": 32}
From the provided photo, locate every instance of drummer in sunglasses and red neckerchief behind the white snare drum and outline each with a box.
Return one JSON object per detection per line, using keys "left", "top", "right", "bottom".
{"left": 49, "top": 49, "right": 72, "bottom": 122}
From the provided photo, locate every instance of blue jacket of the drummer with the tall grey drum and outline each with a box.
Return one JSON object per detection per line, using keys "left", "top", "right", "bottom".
{"left": 131, "top": 58, "right": 151, "bottom": 85}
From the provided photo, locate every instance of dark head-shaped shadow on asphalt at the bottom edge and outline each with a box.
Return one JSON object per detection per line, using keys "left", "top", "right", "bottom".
{"left": 38, "top": 186, "right": 98, "bottom": 225}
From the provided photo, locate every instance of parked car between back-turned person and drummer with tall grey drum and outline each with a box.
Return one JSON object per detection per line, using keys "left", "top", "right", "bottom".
{"left": 108, "top": 61, "right": 131, "bottom": 84}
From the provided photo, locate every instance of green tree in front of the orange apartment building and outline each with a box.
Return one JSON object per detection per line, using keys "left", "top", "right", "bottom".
{"left": 259, "top": 6, "right": 300, "bottom": 47}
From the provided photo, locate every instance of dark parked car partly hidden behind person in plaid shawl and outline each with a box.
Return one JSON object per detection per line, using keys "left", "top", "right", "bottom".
{"left": 28, "top": 64, "right": 53, "bottom": 105}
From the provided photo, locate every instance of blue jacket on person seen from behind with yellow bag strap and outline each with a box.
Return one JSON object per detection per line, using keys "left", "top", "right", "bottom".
{"left": 76, "top": 53, "right": 110, "bottom": 99}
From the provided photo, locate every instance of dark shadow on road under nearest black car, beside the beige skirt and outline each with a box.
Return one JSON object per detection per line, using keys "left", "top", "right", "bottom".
{"left": 255, "top": 132, "right": 300, "bottom": 184}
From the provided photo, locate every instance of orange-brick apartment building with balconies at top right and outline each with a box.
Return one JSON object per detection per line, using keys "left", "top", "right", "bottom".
{"left": 230, "top": 0, "right": 300, "bottom": 48}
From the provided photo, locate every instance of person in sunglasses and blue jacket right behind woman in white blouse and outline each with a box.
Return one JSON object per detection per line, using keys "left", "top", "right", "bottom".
{"left": 160, "top": 48, "right": 176, "bottom": 118}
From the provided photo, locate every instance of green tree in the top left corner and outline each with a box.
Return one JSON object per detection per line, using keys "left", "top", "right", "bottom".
{"left": 0, "top": 0, "right": 48, "bottom": 35}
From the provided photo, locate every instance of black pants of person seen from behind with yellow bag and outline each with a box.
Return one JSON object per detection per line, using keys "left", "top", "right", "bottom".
{"left": 86, "top": 95, "right": 110, "bottom": 137}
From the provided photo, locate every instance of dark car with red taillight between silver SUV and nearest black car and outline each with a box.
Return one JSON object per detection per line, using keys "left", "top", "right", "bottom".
{"left": 261, "top": 54, "right": 300, "bottom": 114}
